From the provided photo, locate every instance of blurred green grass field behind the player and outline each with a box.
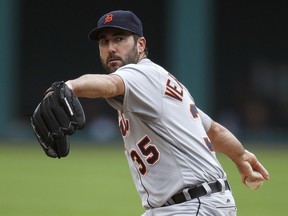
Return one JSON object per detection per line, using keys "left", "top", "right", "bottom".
{"left": 0, "top": 141, "right": 288, "bottom": 216}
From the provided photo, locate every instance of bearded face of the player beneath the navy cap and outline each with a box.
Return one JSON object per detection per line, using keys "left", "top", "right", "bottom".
{"left": 99, "top": 28, "right": 139, "bottom": 73}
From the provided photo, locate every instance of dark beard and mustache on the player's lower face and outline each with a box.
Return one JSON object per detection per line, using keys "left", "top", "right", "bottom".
{"left": 101, "top": 45, "right": 139, "bottom": 73}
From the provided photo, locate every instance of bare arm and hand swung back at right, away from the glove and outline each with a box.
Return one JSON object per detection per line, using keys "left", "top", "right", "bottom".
{"left": 207, "top": 122, "right": 269, "bottom": 184}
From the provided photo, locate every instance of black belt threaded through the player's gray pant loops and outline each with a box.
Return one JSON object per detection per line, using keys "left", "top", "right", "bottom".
{"left": 163, "top": 179, "right": 230, "bottom": 206}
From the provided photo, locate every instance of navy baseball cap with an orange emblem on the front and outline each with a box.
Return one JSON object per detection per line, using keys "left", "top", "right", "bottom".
{"left": 88, "top": 10, "right": 143, "bottom": 41}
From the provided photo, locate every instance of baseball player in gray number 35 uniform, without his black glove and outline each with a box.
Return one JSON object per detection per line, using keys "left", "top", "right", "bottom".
{"left": 38, "top": 10, "right": 269, "bottom": 216}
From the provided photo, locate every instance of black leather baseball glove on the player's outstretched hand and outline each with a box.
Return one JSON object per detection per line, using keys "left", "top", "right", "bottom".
{"left": 31, "top": 81, "right": 85, "bottom": 158}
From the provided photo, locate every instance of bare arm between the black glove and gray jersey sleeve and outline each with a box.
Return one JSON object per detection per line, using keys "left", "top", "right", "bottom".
{"left": 66, "top": 74, "right": 124, "bottom": 98}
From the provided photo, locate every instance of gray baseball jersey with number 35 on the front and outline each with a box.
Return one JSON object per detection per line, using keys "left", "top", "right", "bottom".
{"left": 107, "top": 59, "right": 226, "bottom": 209}
